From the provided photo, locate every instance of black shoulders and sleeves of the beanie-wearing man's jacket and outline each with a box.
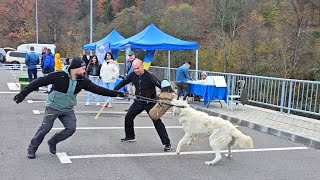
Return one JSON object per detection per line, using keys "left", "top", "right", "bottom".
{"left": 21, "top": 68, "right": 117, "bottom": 97}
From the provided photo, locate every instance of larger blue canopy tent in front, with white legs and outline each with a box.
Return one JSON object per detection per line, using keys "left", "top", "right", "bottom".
{"left": 110, "top": 24, "right": 198, "bottom": 79}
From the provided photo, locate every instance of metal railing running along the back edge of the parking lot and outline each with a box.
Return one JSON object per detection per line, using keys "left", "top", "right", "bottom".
{"left": 0, "top": 63, "right": 320, "bottom": 115}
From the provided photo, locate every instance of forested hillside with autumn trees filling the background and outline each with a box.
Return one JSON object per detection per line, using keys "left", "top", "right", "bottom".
{"left": 0, "top": 0, "right": 320, "bottom": 81}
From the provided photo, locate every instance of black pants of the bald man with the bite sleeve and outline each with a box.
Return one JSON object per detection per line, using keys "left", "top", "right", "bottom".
{"left": 124, "top": 100, "right": 170, "bottom": 144}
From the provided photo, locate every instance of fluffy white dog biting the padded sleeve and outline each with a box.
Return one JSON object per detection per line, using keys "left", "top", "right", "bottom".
{"left": 170, "top": 99, "right": 253, "bottom": 165}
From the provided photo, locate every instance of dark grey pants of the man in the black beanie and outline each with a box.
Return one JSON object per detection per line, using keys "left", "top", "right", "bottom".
{"left": 28, "top": 107, "right": 77, "bottom": 152}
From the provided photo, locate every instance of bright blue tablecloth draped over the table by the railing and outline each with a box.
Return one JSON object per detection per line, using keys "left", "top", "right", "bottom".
{"left": 188, "top": 83, "right": 228, "bottom": 104}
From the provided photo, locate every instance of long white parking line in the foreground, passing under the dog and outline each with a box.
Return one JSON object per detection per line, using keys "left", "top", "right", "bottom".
{"left": 56, "top": 147, "right": 309, "bottom": 164}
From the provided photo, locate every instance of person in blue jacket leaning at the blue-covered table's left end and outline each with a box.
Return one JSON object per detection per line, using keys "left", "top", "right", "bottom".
{"left": 176, "top": 62, "right": 192, "bottom": 100}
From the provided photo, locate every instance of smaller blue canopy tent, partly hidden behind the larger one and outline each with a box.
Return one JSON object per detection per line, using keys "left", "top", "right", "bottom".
{"left": 83, "top": 30, "right": 125, "bottom": 59}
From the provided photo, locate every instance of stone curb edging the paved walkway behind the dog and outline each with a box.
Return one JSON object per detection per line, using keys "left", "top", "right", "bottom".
{"left": 191, "top": 105, "right": 320, "bottom": 149}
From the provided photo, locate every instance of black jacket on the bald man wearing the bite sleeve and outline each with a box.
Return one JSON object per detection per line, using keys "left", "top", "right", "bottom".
{"left": 114, "top": 70, "right": 161, "bottom": 99}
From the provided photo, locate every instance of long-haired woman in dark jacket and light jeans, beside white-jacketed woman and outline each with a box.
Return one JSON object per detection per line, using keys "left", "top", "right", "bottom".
{"left": 85, "top": 55, "right": 101, "bottom": 106}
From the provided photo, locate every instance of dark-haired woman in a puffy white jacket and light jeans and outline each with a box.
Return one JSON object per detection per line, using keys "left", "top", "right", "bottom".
{"left": 100, "top": 52, "right": 120, "bottom": 108}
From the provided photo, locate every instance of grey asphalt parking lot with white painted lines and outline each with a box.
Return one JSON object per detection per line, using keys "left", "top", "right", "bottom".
{"left": 0, "top": 70, "right": 320, "bottom": 180}
